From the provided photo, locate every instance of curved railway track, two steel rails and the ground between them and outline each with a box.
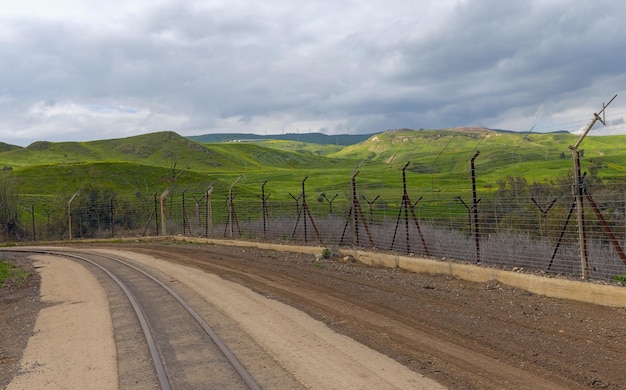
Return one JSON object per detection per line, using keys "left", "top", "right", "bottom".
{"left": 3, "top": 248, "right": 260, "bottom": 390}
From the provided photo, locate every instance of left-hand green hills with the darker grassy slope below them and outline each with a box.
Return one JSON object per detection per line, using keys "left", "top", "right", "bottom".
{"left": 0, "top": 132, "right": 352, "bottom": 200}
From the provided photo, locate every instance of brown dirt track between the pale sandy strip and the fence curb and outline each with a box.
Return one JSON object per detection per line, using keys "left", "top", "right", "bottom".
{"left": 1, "top": 245, "right": 626, "bottom": 389}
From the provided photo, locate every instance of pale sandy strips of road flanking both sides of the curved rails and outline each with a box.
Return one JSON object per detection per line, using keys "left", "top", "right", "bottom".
{"left": 2, "top": 248, "right": 443, "bottom": 390}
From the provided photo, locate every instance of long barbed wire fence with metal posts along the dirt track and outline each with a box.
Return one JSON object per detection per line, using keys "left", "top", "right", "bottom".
{"left": 3, "top": 157, "right": 626, "bottom": 281}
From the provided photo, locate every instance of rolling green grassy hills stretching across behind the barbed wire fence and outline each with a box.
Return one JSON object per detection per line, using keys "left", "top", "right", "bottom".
{"left": 0, "top": 129, "right": 626, "bottom": 207}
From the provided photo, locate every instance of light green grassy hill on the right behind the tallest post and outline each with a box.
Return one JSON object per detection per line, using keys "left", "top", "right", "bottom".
{"left": 329, "top": 129, "right": 626, "bottom": 181}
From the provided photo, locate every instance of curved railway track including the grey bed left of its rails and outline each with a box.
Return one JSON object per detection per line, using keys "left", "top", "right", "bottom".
{"left": 3, "top": 248, "right": 261, "bottom": 390}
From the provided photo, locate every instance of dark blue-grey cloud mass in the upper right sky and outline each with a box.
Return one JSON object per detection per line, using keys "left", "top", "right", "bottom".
{"left": 376, "top": 1, "right": 624, "bottom": 127}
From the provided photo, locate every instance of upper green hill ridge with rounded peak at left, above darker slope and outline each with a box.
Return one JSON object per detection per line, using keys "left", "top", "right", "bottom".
{"left": 0, "top": 132, "right": 342, "bottom": 171}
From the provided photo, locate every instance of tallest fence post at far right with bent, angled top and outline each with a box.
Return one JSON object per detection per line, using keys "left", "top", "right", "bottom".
{"left": 569, "top": 95, "right": 617, "bottom": 279}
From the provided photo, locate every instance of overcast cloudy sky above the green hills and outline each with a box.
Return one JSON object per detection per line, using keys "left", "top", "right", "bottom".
{"left": 0, "top": 0, "right": 626, "bottom": 146}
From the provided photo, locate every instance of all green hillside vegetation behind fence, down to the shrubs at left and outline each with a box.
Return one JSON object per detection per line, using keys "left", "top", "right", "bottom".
{"left": 0, "top": 128, "right": 626, "bottom": 240}
